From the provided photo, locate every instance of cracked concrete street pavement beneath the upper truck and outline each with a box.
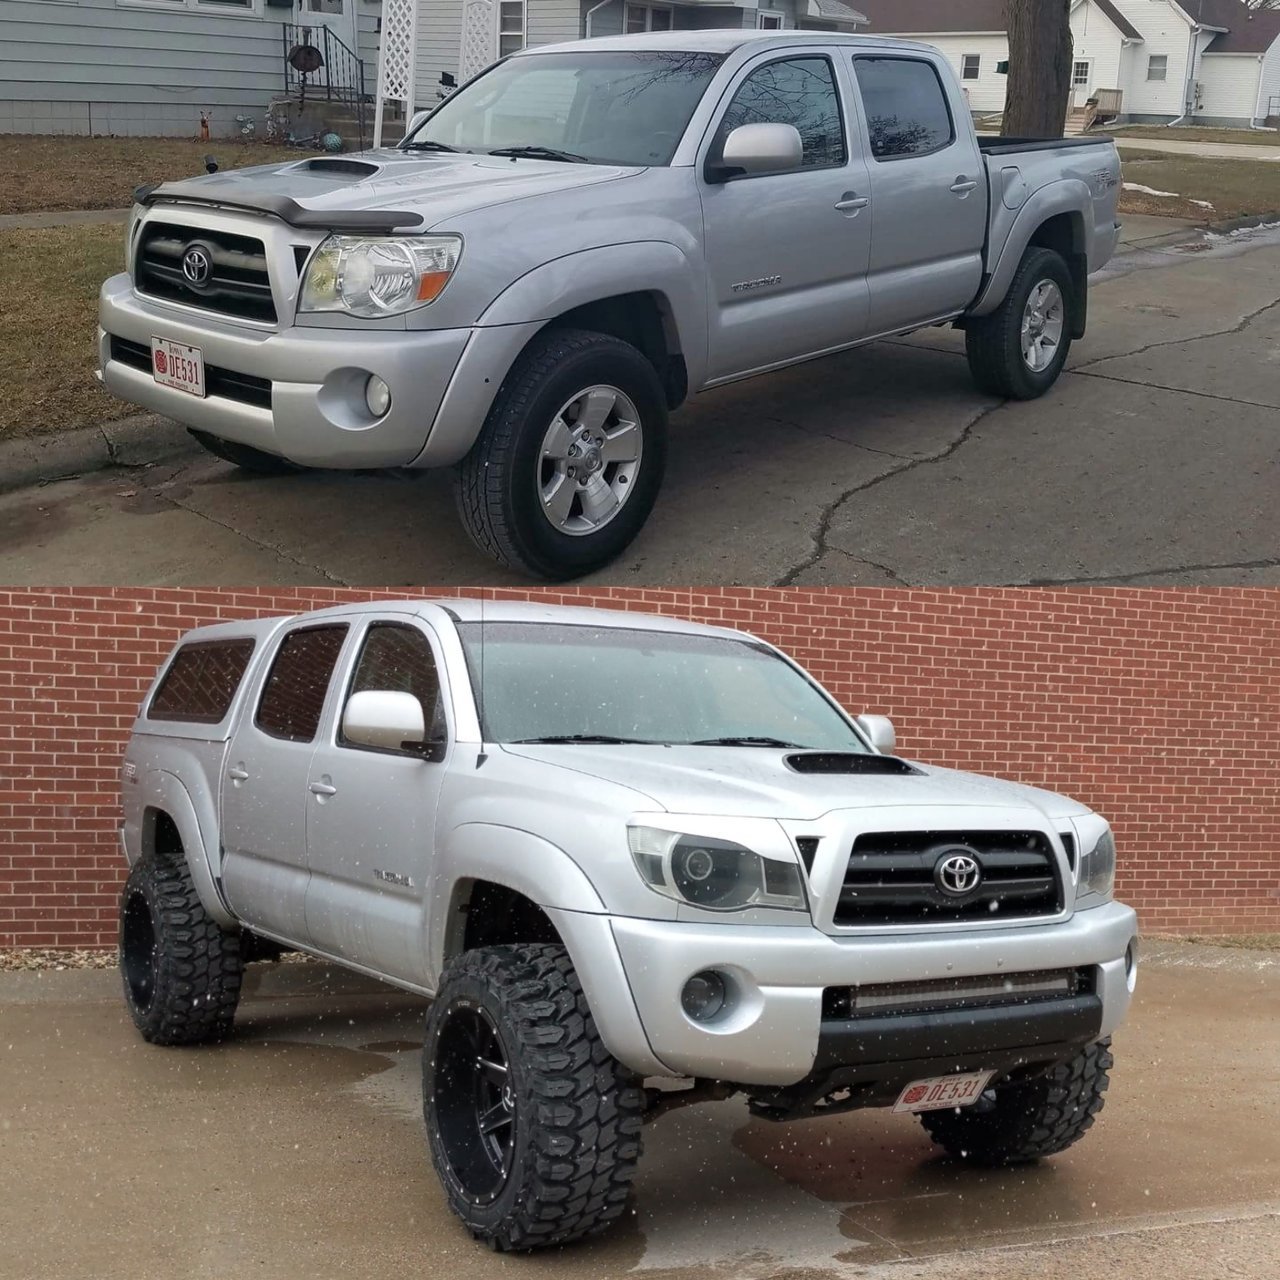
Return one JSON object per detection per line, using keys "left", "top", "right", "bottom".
{"left": 0, "top": 219, "right": 1280, "bottom": 586}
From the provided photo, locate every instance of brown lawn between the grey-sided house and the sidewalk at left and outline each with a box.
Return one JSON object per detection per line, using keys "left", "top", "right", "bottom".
{"left": 0, "top": 134, "right": 307, "bottom": 214}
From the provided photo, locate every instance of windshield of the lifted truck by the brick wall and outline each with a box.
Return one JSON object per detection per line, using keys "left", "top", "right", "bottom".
{"left": 458, "top": 622, "right": 867, "bottom": 753}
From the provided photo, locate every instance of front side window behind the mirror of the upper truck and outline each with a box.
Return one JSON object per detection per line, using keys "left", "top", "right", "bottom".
{"left": 716, "top": 58, "right": 845, "bottom": 168}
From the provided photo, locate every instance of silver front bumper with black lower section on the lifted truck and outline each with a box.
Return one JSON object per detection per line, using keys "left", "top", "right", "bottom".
{"left": 556, "top": 902, "right": 1137, "bottom": 1087}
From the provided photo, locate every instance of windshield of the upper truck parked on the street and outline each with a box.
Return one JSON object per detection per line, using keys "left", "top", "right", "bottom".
{"left": 402, "top": 50, "right": 722, "bottom": 165}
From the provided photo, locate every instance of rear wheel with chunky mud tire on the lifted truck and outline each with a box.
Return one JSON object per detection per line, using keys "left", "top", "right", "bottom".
{"left": 120, "top": 854, "right": 243, "bottom": 1044}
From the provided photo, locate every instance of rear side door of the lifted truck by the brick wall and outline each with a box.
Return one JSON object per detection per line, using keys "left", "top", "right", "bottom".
{"left": 221, "top": 622, "right": 348, "bottom": 943}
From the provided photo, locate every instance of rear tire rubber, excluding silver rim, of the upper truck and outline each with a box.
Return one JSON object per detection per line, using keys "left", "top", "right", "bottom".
{"left": 965, "top": 247, "right": 1075, "bottom": 399}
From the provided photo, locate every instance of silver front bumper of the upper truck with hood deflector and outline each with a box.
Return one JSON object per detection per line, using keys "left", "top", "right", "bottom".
{"left": 99, "top": 275, "right": 476, "bottom": 468}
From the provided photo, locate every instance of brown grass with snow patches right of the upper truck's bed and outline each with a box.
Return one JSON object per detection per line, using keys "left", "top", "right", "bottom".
{"left": 1120, "top": 147, "right": 1280, "bottom": 223}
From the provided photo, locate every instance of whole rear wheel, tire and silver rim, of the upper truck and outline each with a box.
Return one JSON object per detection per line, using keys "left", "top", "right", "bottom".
{"left": 965, "top": 241, "right": 1075, "bottom": 399}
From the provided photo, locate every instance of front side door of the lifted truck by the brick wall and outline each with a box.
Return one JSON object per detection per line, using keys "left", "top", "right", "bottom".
{"left": 306, "top": 618, "right": 448, "bottom": 983}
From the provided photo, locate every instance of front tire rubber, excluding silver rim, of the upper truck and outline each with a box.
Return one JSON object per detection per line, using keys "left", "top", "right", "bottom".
{"left": 454, "top": 329, "right": 667, "bottom": 581}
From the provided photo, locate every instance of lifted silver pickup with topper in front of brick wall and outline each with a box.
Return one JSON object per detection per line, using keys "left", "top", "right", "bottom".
{"left": 120, "top": 600, "right": 1137, "bottom": 1249}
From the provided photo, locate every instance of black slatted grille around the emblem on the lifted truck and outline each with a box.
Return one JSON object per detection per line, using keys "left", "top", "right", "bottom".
{"left": 835, "top": 831, "right": 1062, "bottom": 924}
